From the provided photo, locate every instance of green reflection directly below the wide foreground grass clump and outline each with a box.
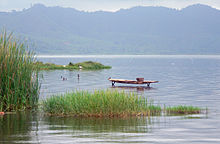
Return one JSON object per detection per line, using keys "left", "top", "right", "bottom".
{"left": 43, "top": 117, "right": 155, "bottom": 133}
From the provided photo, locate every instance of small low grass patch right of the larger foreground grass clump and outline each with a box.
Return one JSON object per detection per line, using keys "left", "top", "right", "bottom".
{"left": 165, "top": 105, "right": 201, "bottom": 114}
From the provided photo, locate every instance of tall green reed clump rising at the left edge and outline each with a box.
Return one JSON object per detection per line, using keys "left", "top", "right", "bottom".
{"left": 0, "top": 31, "right": 39, "bottom": 111}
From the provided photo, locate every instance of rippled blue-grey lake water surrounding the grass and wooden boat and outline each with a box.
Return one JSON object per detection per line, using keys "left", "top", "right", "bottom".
{"left": 0, "top": 56, "right": 220, "bottom": 144}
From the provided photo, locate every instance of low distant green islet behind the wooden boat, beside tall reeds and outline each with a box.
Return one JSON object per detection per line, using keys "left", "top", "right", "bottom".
{"left": 35, "top": 61, "right": 111, "bottom": 70}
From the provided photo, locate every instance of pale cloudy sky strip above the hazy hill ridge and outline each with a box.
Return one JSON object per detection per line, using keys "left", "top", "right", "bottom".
{"left": 0, "top": 0, "right": 220, "bottom": 11}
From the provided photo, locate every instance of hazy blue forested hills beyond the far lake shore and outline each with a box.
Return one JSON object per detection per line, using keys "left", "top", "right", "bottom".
{"left": 0, "top": 4, "right": 220, "bottom": 54}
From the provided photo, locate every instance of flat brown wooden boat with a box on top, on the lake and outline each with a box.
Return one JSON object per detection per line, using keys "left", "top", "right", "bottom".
{"left": 108, "top": 78, "right": 159, "bottom": 87}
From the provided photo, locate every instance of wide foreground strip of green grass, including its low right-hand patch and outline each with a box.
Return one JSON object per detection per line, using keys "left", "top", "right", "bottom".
{"left": 42, "top": 90, "right": 201, "bottom": 117}
